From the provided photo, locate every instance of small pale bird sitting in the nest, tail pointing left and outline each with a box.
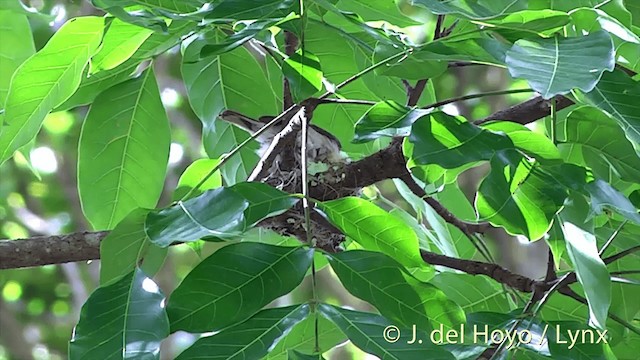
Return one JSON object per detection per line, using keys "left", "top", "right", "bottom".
{"left": 220, "top": 110, "right": 345, "bottom": 164}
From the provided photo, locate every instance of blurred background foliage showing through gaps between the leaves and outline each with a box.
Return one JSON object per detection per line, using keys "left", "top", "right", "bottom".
{"left": 0, "top": 0, "right": 546, "bottom": 360}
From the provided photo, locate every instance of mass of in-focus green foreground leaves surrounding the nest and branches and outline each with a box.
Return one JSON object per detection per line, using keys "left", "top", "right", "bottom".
{"left": 0, "top": 0, "right": 640, "bottom": 359}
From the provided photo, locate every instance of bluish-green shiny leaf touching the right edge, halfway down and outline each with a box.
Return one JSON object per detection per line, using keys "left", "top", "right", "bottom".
{"left": 585, "top": 179, "right": 640, "bottom": 225}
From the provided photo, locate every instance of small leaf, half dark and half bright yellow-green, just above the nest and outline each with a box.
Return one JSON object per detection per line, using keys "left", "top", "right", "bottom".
{"left": 282, "top": 50, "right": 323, "bottom": 104}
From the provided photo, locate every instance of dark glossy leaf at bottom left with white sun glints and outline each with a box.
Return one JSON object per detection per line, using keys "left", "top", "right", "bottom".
{"left": 69, "top": 269, "right": 169, "bottom": 359}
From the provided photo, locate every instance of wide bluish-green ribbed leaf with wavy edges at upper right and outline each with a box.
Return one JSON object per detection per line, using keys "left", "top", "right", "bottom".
{"left": 506, "top": 31, "right": 615, "bottom": 99}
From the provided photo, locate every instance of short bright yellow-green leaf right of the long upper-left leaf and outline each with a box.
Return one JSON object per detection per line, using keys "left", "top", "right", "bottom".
{"left": 91, "top": 19, "right": 152, "bottom": 74}
